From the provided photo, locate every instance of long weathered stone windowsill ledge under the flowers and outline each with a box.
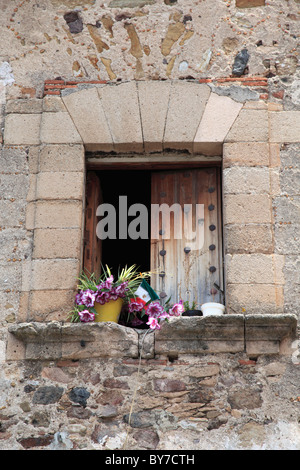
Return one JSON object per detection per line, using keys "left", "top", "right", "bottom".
{"left": 7, "top": 315, "right": 297, "bottom": 360}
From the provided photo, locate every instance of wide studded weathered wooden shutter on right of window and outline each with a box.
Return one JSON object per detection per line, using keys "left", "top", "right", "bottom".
{"left": 151, "top": 168, "right": 223, "bottom": 307}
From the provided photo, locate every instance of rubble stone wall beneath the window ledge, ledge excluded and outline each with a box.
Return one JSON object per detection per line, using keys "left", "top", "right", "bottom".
{"left": 0, "top": 354, "right": 300, "bottom": 450}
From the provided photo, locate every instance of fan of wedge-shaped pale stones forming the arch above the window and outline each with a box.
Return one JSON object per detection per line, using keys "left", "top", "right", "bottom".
{"left": 55, "top": 81, "right": 243, "bottom": 155}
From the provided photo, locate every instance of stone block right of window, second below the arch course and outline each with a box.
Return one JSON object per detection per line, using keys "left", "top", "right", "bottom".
{"left": 223, "top": 167, "right": 270, "bottom": 194}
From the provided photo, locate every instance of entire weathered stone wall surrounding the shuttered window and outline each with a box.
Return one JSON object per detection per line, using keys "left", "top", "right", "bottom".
{"left": 0, "top": 0, "right": 300, "bottom": 450}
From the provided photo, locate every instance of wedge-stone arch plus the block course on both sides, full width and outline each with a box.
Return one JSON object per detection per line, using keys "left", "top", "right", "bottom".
{"left": 3, "top": 80, "right": 300, "bottom": 151}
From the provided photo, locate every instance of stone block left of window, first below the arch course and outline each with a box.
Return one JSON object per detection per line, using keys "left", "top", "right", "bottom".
{"left": 39, "top": 145, "right": 84, "bottom": 172}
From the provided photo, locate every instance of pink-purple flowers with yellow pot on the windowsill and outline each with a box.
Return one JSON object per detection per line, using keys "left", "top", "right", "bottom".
{"left": 69, "top": 266, "right": 184, "bottom": 330}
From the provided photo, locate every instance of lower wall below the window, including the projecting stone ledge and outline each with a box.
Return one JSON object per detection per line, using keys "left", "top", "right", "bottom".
{"left": 0, "top": 315, "right": 300, "bottom": 451}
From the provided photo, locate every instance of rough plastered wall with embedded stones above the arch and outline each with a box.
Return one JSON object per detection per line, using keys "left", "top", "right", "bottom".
{"left": 0, "top": 0, "right": 299, "bottom": 98}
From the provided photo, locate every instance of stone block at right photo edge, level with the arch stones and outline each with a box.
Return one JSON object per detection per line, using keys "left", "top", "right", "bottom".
{"left": 269, "top": 111, "right": 300, "bottom": 143}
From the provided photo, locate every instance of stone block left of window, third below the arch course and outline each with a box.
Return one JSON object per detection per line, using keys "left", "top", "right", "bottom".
{"left": 33, "top": 201, "right": 82, "bottom": 228}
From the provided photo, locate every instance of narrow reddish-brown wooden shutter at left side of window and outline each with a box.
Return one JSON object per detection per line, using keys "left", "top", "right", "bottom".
{"left": 83, "top": 171, "right": 102, "bottom": 277}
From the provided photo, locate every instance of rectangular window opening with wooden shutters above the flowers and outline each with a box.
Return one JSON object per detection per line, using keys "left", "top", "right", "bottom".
{"left": 84, "top": 164, "right": 224, "bottom": 305}
